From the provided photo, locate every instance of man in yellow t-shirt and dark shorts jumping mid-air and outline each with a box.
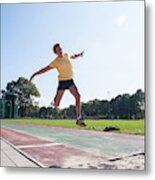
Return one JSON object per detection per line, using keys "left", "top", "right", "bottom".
{"left": 30, "top": 44, "right": 86, "bottom": 127}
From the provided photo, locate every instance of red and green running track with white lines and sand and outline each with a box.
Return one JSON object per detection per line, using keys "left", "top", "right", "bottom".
{"left": 1, "top": 122, "right": 144, "bottom": 169}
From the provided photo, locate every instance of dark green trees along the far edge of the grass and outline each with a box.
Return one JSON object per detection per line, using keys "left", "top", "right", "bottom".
{"left": 3, "top": 77, "right": 145, "bottom": 119}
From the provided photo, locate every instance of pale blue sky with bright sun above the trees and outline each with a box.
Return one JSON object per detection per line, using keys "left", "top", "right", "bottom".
{"left": 1, "top": 1, "right": 144, "bottom": 108}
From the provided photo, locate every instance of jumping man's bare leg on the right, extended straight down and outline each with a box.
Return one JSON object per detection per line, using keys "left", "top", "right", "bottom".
{"left": 69, "top": 85, "right": 81, "bottom": 117}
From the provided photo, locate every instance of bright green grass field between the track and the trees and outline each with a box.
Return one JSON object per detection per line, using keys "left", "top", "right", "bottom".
{"left": 2, "top": 119, "right": 144, "bottom": 135}
